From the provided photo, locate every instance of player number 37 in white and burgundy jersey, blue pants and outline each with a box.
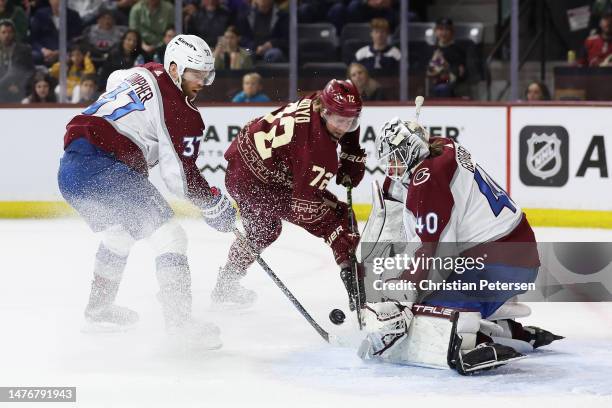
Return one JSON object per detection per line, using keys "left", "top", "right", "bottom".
{"left": 58, "top": 35, "right": 236, "bottom": 348}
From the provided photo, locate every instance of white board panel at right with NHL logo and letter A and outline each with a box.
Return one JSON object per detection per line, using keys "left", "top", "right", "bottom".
{"left": 510, "top": 106, "right": 612, "bottom": 210}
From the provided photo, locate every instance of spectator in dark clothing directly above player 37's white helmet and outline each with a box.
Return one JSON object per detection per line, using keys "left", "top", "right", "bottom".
{"left": 186, "top": 0, "right": 232, "bottom": 48}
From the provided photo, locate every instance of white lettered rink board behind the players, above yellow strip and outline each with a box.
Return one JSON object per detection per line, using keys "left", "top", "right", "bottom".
{"left": 0, "top": 106, "right": 506, "bottom": 204}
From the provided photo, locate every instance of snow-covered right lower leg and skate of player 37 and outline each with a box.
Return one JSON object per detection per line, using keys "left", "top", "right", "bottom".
{"left": 157, "top": 254, "right": 222, "bottom": 350}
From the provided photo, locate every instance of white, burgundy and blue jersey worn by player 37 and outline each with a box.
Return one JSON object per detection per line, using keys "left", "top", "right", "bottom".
{"left": 64, "top": 63, "right": 211, "bottom": 205}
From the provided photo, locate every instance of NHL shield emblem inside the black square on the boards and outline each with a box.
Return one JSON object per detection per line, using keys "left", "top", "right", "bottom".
{"left": 526, "top": 133, "right": 562, "bottom": 180}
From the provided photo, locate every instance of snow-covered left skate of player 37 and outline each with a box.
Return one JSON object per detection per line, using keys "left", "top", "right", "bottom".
{"left": 83, "top": 276, "right": 138, "bottom": 332}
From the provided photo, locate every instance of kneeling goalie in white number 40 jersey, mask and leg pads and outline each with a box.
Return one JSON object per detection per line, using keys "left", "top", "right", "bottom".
{"left": 360, "top": 98, "right": 561, "bottom": 374}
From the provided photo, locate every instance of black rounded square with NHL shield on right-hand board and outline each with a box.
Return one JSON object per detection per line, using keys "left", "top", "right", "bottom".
{"left": 519, "top": 126, "right": 569, "bottom": 187}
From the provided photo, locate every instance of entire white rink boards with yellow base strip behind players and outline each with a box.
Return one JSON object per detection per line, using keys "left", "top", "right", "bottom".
{"left": 0, "top": 101, "right": 612, "bottom": 228}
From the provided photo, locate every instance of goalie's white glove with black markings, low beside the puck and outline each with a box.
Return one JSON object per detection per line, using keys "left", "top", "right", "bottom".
{"left": 357, "top": 302, "right": 413, "bottom": 359}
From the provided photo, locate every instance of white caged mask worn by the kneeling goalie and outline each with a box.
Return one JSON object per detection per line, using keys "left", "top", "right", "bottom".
{"left": 376, "top": 117, "right": 429, "bottom": 183}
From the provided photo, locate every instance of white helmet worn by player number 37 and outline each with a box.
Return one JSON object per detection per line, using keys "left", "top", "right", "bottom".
{"left": 164, "top": 34, "right": 215, "bottom": 89}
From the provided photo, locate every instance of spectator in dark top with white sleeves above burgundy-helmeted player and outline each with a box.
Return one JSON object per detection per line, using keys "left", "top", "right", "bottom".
{"left": 355, "top": 18, "right": 401, "bottom": 74}
